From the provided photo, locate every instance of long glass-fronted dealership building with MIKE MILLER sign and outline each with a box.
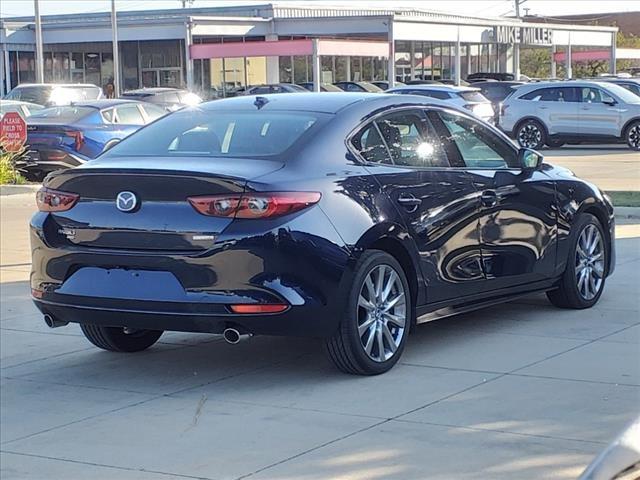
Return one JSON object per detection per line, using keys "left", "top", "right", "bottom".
{"left": 0, "top": 2, "right": 617, "bottom": 97}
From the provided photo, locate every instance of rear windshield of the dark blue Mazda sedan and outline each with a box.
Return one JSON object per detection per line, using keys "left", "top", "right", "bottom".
{"left": 105, "top": 108, "right": 326, "bottom": 158}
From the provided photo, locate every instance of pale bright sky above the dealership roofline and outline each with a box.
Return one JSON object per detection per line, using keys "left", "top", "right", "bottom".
{"left": 0, "top": 0, "right": 640, "bottom": 17}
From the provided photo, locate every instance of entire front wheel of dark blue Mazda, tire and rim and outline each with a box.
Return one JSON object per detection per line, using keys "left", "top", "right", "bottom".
{"left": 547, "top": 213, "right": 609, "bottom": 309}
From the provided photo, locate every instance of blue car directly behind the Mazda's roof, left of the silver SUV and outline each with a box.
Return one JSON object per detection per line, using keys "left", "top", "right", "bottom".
{"left": 387, "top": 84, "right": 494, "bottom": 122}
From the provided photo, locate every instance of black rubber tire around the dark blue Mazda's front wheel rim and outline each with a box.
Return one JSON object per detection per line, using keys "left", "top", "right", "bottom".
{"left": 547, "top": 213, "right": 610, "bottom": 309}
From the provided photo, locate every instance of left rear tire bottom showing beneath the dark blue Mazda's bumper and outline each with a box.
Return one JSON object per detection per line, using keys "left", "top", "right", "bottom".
{"left": 80, "top": 324, "right": 163, "bottom": 352}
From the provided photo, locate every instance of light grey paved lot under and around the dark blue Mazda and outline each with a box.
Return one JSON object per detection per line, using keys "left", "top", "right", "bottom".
{"left": 0, "top": 147, "right": 640, "bottom": 480}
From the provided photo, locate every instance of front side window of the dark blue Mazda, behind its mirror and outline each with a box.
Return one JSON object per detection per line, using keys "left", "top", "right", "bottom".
{"left": 431, "top": 111, "right": 518, "bottom": 169}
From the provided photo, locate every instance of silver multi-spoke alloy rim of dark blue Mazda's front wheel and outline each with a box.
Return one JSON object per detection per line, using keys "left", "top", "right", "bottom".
{"left": 576, "top": 224, "right": 605, "bottom": 300}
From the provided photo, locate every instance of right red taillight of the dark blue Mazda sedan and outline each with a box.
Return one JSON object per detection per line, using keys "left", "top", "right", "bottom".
{"left": 188, "top": 192, "right": 321, "bottom": 218}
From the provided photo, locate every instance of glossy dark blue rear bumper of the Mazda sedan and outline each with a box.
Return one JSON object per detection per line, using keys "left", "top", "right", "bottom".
{"left": 31, "top": 208, "right": 352, "bottom": 337}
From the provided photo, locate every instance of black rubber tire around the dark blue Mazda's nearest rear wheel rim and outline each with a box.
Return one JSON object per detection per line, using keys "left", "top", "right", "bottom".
{"left": 325, "top": 250, "right": 413, "bottom": 375}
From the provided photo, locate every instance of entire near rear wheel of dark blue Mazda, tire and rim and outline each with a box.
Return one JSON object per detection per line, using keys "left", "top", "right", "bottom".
{"left": 326, "top": 250, "right": 412, "bottom": 375}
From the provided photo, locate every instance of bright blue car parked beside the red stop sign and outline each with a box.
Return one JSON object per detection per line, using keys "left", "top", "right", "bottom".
{"left": 16, "top": 100, "right": 167, "bottom": 181}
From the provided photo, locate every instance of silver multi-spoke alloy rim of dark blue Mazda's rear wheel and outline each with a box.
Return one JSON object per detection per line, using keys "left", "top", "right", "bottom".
{"left": 358, "top": 264, "right": 407, "bottom": 362}
